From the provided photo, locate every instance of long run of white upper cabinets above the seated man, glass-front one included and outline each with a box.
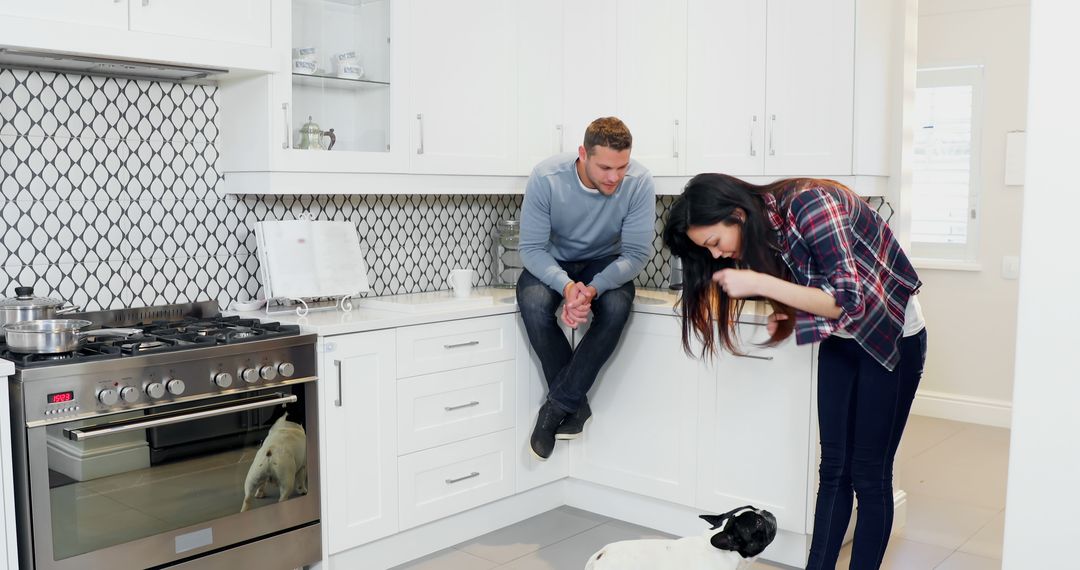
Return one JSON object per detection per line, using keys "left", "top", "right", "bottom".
{"left": 214, "top": 0, "right": 902, "bottom": 193}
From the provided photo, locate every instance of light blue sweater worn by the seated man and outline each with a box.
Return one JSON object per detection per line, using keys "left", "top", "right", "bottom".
{"left": 519, "top": 153, "right": 657, "bottom": 295}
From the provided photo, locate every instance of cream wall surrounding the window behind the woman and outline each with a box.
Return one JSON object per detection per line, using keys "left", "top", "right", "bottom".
{"left": 915, "top": 0, "right": 1029, "bottom": 425}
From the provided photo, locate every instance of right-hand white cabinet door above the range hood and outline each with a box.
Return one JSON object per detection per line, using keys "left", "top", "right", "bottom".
{"left": 127, "top": 0, "right": 270, "bottom": 46}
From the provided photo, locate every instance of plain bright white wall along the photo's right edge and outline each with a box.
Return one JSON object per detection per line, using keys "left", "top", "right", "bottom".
{"left": 1002, "top": 0, "right": 1080, "bottom": 570}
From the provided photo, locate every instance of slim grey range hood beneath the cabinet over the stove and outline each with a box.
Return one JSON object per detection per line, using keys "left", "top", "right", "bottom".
{"left": 0, "top": 48, "right": 229, "bottom": 81}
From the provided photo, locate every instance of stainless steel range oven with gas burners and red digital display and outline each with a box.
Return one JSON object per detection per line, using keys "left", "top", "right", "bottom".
{"left": 7, "top": 303, "right": 321, "bottom": 570}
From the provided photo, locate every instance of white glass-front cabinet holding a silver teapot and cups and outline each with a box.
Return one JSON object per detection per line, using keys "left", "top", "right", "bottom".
{"left": 218, "top": 0, "right": 409, "bottom": 193}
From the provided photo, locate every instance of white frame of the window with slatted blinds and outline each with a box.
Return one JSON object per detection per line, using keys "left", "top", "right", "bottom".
{"left": 910, "top": 64, "right": 985, "bottom": 264}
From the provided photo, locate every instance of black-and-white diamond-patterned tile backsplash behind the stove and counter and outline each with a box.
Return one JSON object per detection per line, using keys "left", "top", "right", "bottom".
{"left": 0, "top": 68, "right": 672, "bottom": 310}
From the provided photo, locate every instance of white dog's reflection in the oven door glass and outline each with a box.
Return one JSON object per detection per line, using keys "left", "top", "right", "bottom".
{"left": 240, "top": 412, "right": 308, "bottom": 513}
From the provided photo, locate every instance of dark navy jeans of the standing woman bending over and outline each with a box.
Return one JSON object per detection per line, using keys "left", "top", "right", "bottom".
{"left": 807, "top": 329, "right": 927, "bottom": 570}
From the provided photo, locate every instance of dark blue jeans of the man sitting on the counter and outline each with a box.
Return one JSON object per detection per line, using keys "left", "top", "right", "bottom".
{"left": 517, "top": 256, "right": 634, "bottom": 413}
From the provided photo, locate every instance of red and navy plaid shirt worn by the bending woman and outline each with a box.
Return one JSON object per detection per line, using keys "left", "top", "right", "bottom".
{"left": 765, "top": 185, "right": 922, "bottom": 370}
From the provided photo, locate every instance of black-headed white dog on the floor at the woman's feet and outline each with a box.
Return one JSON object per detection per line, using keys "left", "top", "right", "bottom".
{"left": 585, "top": 506, "right": 777, "bottom": 570}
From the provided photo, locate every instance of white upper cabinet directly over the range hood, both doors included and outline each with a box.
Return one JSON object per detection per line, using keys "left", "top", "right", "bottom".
{"left": 0, "top": 0, "right": 274, "bottom": 72}
